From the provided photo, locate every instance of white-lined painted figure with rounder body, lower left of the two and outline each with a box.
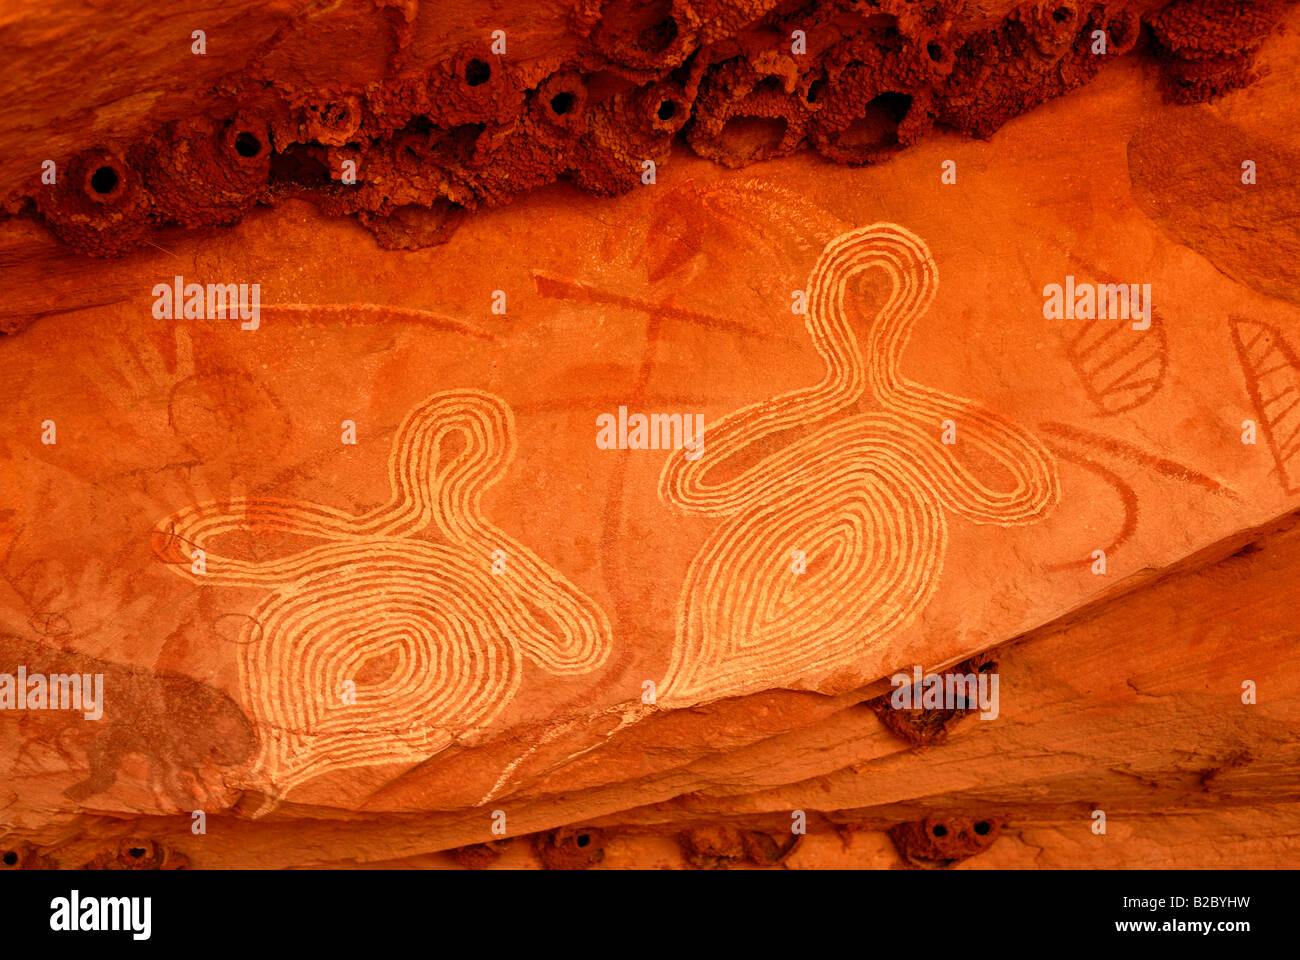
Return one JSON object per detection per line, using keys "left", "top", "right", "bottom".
{"left": 155, "top": 390, "right": 610, "bottom": 795}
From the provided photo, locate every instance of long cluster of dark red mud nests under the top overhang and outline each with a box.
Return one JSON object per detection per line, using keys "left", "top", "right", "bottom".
{"left": 15, "top": 0, "right": 1286, "bottom": 255}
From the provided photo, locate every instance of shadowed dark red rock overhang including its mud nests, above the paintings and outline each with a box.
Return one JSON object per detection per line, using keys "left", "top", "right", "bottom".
{"left": 0, "top": 0, "right": 1284, "bottom": 255}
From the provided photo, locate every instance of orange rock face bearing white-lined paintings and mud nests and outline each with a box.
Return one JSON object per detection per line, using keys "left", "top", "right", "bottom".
{"left": 0, "top": 0, "right": 1300, "bottom": 869}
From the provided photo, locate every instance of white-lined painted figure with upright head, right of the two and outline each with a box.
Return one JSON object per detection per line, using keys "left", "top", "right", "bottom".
{"left": 659, "top": 224, "right": 1060, "bottom": 704}
